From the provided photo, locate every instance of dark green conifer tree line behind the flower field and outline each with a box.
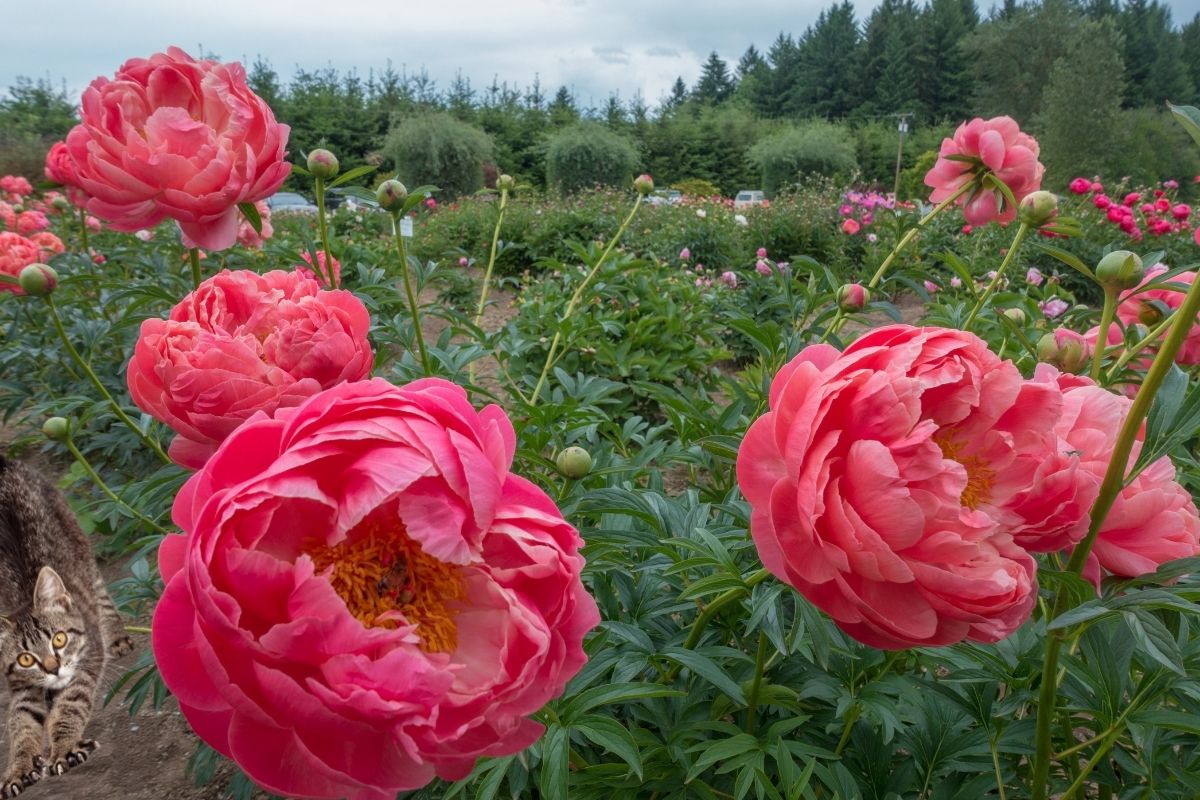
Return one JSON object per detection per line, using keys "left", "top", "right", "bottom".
{"left": 7, "top": 0, "right": 1200, "bottom": 193}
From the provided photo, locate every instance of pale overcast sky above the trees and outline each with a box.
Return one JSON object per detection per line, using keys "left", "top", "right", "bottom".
{"left": 7, "top": 0, "right": 1200, "bottom": 107}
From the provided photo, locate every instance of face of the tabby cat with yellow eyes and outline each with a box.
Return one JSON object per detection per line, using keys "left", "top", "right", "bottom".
{"left": 0, "top": 567, "right": 88, "bottom": 691}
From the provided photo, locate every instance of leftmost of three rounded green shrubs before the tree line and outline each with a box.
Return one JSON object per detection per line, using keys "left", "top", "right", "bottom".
{"left": 384, "top": 114, "right": 493, "bottom": 198}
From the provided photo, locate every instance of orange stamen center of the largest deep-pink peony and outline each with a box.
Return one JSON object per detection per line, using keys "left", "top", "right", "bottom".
{"left": 307, "top": 522, "right": 466, "bottom": 652}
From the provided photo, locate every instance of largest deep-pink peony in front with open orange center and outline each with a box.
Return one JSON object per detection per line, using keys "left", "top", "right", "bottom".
{"left": 152, "top": 379, "right": 599, "bottom": 800}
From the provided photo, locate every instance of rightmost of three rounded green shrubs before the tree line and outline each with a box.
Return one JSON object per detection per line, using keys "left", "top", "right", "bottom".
{"left": 748, "top": 122, "right": 858, "bottom": 197}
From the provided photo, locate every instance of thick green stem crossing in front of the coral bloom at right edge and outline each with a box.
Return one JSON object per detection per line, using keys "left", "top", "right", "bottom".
{"left": 1032, "top": 260, "right": 1200, "bottom": 800}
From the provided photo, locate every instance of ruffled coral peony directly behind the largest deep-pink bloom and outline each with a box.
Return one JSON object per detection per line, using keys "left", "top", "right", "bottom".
{"left": 128, "top": 270, "right": 373, "bottom": 469}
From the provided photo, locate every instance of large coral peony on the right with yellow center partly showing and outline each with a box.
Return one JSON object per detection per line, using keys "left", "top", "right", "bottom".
{"left": 737, "top": 325, "right": 1041, "bottom": 648}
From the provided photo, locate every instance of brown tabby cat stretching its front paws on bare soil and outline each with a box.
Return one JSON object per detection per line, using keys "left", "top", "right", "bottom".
{"left": 0, "top": 456, "right": 133, "bottom": 798}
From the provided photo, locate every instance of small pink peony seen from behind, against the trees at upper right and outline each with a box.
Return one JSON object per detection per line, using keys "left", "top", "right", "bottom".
{"left": 925, "top": 116, "right": 1045, "bottom": 225}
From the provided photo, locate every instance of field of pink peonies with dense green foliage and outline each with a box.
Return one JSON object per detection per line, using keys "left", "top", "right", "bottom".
{"left": 0, "top": 48, "right": 1200, "bottom": 800}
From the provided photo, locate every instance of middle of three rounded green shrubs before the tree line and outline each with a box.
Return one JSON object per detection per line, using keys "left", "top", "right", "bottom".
{"left": 546, "top": 122, "right": 638, "bottom": 194}
